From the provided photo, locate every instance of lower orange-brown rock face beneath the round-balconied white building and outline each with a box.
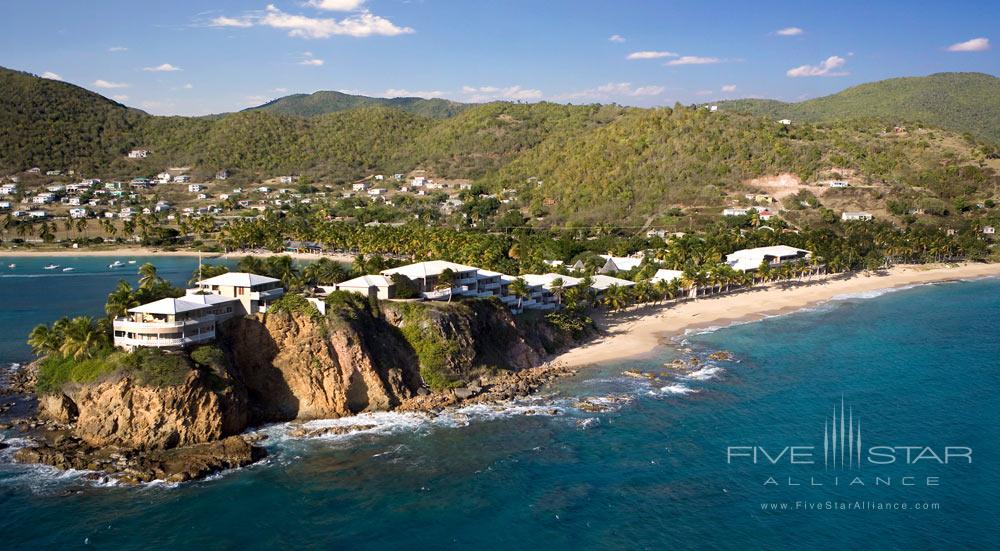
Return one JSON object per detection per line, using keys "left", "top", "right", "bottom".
{"left": 39, "top": 370, "right": 247, "bottom": 449}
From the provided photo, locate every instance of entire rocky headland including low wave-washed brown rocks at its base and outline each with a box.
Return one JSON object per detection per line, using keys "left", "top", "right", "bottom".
{"left": 17, "top": 301, "right": 580, "bottom": 482}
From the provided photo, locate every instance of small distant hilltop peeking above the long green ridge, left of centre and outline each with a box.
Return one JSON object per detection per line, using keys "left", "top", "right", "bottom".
{"left": 250, "top": 91, "right": 468, "bottom": 119}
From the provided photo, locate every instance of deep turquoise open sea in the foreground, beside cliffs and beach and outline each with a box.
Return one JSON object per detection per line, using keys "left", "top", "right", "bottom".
{"left": 0, "top": 260, "right": 1000, "bottom": 549}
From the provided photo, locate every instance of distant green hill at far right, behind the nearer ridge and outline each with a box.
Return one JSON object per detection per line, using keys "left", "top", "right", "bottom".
{"left": 718, "top": 73, "right": 1000, "bottom": 144}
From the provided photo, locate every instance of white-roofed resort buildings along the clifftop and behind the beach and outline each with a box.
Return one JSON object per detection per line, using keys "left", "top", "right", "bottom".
{"left": 113, "top": 245, "right": 811, "bottom": 350}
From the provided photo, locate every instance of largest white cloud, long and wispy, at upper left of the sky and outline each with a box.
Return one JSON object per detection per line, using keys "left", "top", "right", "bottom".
{"left": 208, "top": 4, "right": 415, "bottom": 39}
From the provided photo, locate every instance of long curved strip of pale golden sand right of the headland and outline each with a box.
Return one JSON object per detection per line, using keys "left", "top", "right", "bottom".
{"left": 550, "top": 263, "right": 1000, "bottom": 368}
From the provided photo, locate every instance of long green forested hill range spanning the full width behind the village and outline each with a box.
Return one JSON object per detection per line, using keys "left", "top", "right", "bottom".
{"left": 0, "top": 70, "right": 1000, "bottom": 224}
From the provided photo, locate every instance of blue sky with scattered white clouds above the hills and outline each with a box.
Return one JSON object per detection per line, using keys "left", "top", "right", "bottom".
{"left": 0, "top": 0, "right": 1000, "bottom": 115}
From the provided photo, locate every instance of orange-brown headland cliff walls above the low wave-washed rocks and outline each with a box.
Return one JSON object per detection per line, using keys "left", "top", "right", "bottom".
{"left": 27, "top": 297, "right": 571, "bottom": 480}
